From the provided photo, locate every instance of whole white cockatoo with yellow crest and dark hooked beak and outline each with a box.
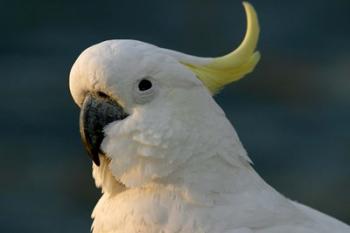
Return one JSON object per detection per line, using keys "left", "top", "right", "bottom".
{"left": 70, "top": 2, "right": 350, "bottom": 233}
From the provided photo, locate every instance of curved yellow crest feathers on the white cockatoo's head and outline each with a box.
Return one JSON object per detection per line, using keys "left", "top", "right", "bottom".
{"left": 182, "top": 2, "right": 260, "bottom": 94}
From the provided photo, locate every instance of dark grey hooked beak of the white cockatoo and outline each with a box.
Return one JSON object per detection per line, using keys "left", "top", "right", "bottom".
{"left": 79, "top": 93, "right": 128, "bottom": 166}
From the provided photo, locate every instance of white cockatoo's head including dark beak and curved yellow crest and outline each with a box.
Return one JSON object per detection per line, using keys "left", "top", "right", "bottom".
{"left": 70, "top": 3, "right": 260, "bottom": 187}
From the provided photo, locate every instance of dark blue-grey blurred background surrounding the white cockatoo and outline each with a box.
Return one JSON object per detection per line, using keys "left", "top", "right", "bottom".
{"left": 0, "top": 0, "right": 350, "bottom": 233}
